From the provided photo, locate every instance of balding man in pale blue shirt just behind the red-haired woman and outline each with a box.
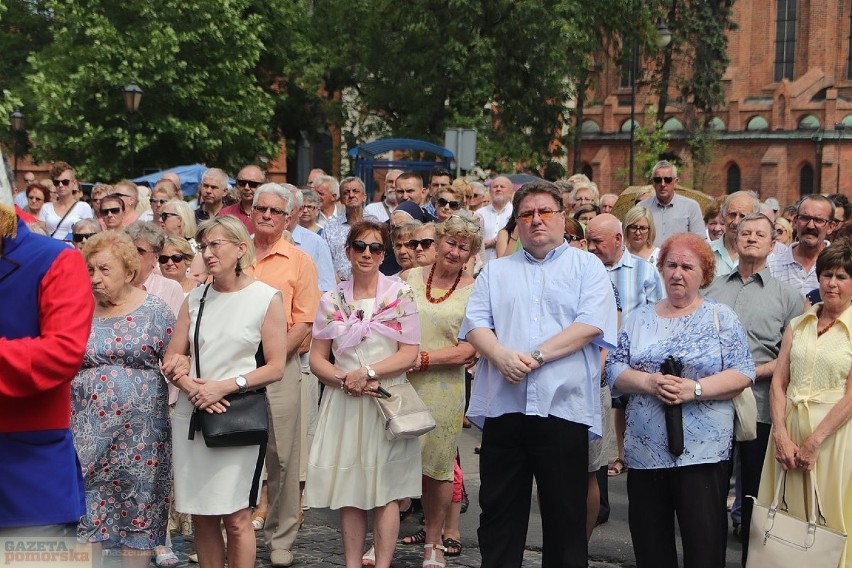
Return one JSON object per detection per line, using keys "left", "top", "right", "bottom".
{"left": 586, "top": 213, "right": 665, "bottom": 319}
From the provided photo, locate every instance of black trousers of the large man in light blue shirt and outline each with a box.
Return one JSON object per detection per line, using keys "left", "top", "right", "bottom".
{"left": 478, "top": 414, "right": 589, "bottom": 568}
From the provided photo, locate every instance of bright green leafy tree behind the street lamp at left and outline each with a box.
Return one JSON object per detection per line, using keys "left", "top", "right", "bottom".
{"left": 27, "top": 0, "right": 276, "bottom": 179}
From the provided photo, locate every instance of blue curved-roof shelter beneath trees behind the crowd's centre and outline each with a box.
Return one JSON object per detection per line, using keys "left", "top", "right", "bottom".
{"left": 348, "top": 138, "right": 454, "bottom": 199}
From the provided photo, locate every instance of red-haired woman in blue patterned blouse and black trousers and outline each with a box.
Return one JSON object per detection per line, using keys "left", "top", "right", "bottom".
{"left": 606, "top": 233, "right": 754, "bottom": 568}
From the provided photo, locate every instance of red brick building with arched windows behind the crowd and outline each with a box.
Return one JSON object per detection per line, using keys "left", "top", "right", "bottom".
{"left": 581, "top": 0, "right": 852, "bottom": 205}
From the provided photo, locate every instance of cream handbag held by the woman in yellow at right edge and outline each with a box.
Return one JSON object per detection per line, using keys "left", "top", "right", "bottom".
{"left": 748, "top": 471, "right": 846, "bottom": 568}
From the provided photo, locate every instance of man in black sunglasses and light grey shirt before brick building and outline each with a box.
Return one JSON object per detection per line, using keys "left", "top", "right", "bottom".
{"left": 638, "top": 160, "right": 706, "bottom": 246}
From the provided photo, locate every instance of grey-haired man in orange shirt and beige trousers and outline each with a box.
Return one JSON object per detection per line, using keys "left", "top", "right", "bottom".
{"left": 248, "top": 183, "right": 320, "bottom": 566}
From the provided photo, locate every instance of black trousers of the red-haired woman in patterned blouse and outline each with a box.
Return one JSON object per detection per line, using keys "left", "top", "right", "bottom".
{"left": 627, "top": 461, "right": 730, "bottom": 568}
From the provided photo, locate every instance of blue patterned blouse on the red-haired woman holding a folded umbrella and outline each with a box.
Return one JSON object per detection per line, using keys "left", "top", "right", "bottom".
{"left": 606, "top": 301, "right": 754, "bottom": 469}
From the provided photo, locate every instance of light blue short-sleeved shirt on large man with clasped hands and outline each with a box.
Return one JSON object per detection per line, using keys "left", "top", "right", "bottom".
{"left": 459, "top": 243, "right": 617, "bottom": 436}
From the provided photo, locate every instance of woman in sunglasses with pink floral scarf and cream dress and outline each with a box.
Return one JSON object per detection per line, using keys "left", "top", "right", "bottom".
{"left": 305, "top": 221, "right": 421, "bottom": 568}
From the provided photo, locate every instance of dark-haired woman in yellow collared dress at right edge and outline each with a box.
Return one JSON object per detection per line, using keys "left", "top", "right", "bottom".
{"left": 758, "top": 243, "right": 852, "bottom": 568}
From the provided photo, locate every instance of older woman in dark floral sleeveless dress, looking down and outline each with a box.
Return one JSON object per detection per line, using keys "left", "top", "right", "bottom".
{"left": 71, "top": 231, "right": 175, "bottom": 566}
